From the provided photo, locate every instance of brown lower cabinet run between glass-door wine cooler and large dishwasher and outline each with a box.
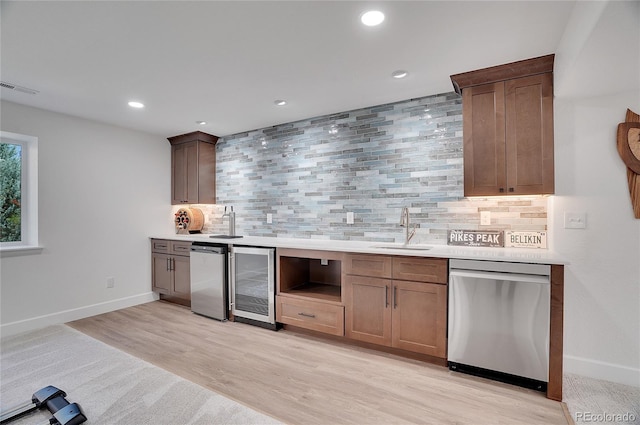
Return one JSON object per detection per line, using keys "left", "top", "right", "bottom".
{"left": 276, "top": 248, "right": 448, "bottom": 358}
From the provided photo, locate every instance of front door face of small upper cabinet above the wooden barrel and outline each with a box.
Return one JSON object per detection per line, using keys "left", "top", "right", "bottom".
{"left": 171, "top": 142, "right": 198, "bottom": 205}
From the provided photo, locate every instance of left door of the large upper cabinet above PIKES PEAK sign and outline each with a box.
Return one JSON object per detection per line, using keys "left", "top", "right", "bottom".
{"left": 462, "top": 82, "right": 507, "bottom": 196}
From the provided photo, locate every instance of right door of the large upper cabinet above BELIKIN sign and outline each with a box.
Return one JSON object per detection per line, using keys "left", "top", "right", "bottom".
{"left": 504, "top": 74, "right": 554, "bottom": 195}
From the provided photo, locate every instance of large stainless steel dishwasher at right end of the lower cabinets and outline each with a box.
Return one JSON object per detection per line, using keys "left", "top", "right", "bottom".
{"left": 447, "top": 259, "right": 551, "bottom": 391}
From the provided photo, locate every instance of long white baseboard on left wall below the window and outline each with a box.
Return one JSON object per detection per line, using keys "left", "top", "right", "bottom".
{"left": 0, "top": 292, "right": 158, "bottom": 337}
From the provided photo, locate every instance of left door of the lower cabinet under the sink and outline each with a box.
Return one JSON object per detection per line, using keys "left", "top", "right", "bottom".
{"left": 345, "top": 276, "right": 391, "bottom": 346}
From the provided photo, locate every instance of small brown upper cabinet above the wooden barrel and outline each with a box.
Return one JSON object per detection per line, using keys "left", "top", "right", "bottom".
{"left": 168, "top": 131, "right": 218, "bottom": 205}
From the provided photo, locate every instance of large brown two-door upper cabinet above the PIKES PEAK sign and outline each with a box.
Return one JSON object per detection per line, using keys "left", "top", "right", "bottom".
{"left": 451, "top": 55, "right": 554, "bottom": 196}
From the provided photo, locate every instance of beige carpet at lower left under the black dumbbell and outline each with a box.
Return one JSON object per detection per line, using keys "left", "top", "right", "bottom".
{"left": 0, "top": 325, "right": 280, "bottom": 425}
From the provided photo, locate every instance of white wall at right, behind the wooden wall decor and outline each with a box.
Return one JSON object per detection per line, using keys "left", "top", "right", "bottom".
{"left": 549, "top": 2, "right": 640, "bottom": 386}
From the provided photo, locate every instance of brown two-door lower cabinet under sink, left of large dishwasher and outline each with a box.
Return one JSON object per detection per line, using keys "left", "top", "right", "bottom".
{"left": 343, "top": 255, "right": 447, "bottom": 358}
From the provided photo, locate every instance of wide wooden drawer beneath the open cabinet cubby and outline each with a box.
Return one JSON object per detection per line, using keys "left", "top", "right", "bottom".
{"left": 276, "top": 296, "right": 344, "bottom": 336}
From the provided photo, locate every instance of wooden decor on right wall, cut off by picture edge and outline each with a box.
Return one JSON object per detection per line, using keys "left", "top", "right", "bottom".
{"left": 618, "top": 109, "right": 640, "bottom": 218}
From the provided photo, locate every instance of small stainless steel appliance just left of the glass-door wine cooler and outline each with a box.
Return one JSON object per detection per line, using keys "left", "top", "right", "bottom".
{"left": 189, "top": 242, "right": 228, "bottom": 321}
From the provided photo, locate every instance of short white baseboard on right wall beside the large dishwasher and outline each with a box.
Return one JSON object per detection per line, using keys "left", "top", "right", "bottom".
{"left": 563, "top": 355, "right": 640, "bottom": 387}
